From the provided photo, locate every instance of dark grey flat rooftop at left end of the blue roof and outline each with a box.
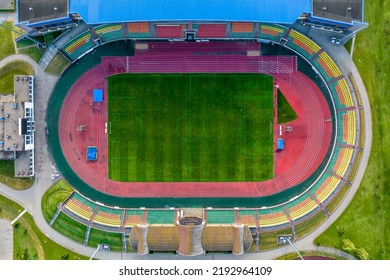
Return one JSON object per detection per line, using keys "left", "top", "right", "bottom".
{"left": 18, "top": 0, "right": 68, "bottom": 23}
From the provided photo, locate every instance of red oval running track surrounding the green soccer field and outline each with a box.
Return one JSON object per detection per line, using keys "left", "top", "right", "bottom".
{"left": 59, "top": 46, "right": 332, "bottom": 197}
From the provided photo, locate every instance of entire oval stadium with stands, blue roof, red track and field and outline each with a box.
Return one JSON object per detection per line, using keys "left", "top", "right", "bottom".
{"left": 17, "top": 0, "right": 367, "bottom": 256}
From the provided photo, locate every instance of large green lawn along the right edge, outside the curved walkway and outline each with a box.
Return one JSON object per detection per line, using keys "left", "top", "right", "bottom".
{"left": 316, "top": 0, "right": 390, "bottom": 260}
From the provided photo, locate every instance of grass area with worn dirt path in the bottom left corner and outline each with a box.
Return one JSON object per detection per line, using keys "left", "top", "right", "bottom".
{"left": 0, "top": 192, "right": 86, "bottom": 260}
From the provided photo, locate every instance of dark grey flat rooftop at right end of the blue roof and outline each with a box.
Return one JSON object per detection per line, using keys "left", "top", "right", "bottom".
{"left": 313, "top": 0, "right": 364, "bottom": 23}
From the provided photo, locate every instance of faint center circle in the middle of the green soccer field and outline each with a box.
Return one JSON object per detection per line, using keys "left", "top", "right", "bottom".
{"left": 176, "top": 113, "right": 206, "bottom": 142}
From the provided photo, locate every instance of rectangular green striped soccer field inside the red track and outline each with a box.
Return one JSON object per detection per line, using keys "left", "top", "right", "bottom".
{"left": 108, "top": 74, "right": 273, "bottom": 182}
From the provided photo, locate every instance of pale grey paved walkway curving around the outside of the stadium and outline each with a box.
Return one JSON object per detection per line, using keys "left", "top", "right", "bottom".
{"left": 0, "top": 28, "right": 372, "bottom": 260}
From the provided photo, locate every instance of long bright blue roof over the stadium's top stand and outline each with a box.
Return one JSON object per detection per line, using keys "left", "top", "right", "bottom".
{"left": 69, "top": 0, "right": 312, "bottom": 24}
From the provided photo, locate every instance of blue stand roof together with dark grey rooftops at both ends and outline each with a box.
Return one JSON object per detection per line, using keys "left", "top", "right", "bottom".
{"left": 16, "top": 0, "right": 367, "bottom": 43}
